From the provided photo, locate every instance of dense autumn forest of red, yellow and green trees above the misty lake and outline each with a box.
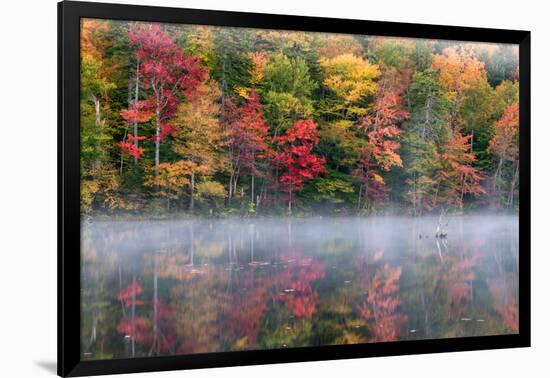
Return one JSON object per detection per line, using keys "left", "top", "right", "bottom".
{"left": 80, "top": 19, "right": 519, "bottom": 216}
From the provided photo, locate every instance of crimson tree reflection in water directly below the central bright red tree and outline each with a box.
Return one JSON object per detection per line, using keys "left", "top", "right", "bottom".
{"left": 276, "top": 249, "right": 325, "bottom": 318}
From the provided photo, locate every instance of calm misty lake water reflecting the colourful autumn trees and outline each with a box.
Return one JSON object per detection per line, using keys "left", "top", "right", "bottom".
{"left": 81, "top": 216, "right": 518, "bottom": 359}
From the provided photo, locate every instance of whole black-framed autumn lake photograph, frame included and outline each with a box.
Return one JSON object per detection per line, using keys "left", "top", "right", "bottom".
{"left": 58, "top": 1, "right": 530, "bottom": 376}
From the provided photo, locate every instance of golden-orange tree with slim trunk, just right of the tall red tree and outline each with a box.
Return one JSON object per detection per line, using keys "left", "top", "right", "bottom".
{"left": 173, "top": 81, "right": 227, "bottom": 210}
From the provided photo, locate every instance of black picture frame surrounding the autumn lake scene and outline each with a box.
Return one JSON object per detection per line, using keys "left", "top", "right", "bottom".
{"left": 58, "top": 1, "right": 531, "bottom": 377}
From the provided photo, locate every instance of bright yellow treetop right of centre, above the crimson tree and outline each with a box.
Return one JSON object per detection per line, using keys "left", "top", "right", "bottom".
{"left": 320, "top": 54, "right": 380, "bottom": 118}
